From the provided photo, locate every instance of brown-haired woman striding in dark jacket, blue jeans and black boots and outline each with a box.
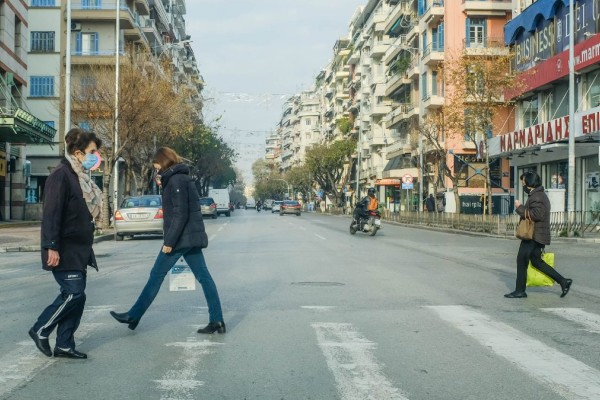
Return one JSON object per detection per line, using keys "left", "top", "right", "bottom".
{"left": 110, "top": 147, "right": 225, "bottom": 333}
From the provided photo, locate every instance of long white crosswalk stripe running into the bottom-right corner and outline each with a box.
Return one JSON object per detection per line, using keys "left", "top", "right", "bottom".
{"left": 428, "top": 306, "right": 600, "bottom": 400}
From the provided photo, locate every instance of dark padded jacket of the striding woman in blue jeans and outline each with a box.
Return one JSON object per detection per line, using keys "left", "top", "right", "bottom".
{"left": 160, "top": 164, "right": 208, "bottom": 249}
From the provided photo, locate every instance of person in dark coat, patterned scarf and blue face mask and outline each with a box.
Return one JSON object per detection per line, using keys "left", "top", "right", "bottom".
{"left": 29, "top": 128, "right": 102, "bottom": 359}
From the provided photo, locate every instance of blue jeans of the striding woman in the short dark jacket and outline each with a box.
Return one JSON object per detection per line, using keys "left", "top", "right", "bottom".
{"left": 128, "top": 247, "right": 223, "bottom": 322}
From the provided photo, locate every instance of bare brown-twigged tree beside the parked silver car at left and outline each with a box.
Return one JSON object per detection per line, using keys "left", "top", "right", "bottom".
{"left": 72, "top": 47, "right": 198, "bottom": 227}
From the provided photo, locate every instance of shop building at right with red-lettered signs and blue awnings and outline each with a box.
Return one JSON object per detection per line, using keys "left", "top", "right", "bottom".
{"left": 490, "top": 0, "right": 600, "bottom": 215}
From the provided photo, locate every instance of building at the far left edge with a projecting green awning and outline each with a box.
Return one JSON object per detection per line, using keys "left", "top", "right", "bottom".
{"left": 0, "top": 0, "right": 56, "bottom": 220}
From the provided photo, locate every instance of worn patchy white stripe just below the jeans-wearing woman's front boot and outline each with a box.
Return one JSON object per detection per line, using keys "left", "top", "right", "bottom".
{"left": 154, "top": 337, "right": 222, "bottom": 400}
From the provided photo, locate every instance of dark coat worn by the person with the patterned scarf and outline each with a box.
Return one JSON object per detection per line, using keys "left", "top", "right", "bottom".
{"left": 40, "top": 158, "right": 97, "bottom": 271}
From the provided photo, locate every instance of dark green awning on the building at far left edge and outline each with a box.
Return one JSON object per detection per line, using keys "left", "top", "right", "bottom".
{"left": 0, "top": 108, "right": 56, "bottom": 144}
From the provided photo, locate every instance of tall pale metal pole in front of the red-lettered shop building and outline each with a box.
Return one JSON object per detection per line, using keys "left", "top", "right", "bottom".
{"left": 567, "top": 0, "right": 577, "bottom": 211}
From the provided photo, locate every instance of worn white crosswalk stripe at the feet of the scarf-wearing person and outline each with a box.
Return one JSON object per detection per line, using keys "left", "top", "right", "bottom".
{"left": 0, "top": 306, "right": 112, "bottom": 397}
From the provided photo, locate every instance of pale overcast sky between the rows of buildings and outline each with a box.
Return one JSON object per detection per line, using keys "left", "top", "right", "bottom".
{"left": 185, "top": 0, "right": 367, "bottom": 183}
